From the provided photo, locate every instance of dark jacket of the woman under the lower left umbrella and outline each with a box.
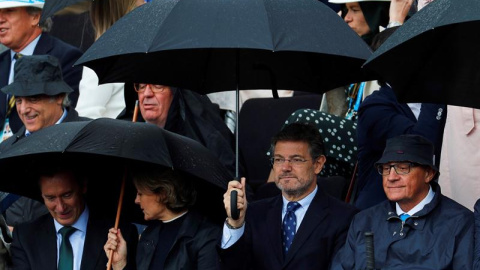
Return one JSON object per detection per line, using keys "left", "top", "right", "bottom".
{"left": 137, "top": 211, "right": 220, "bottom": 270}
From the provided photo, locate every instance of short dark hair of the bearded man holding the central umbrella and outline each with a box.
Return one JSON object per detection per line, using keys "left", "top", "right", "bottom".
{"left": 270, "top": 122, "right": 325, "bottom": 159}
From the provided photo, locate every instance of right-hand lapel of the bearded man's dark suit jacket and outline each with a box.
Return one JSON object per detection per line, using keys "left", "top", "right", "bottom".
{"left": 280, "top": 192, "right": 328, "bottom": 266}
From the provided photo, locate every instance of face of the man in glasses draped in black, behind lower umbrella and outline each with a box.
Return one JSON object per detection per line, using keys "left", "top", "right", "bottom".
{"left": 138, "top": 84, "right": 173, "bottom": 128}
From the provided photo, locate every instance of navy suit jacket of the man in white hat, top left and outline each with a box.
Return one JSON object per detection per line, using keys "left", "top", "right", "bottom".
{"left": 0, "top": 33, "right": 83, "bottom": 133}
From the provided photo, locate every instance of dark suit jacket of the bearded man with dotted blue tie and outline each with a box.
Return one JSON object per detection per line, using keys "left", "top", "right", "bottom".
{"left": 218, "top": 189, "right": 358, "bottom": 270}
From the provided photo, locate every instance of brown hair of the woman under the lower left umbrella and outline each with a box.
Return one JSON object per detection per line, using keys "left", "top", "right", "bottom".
{"left": 131, "top": 166, "right": 197, "bottom": 213}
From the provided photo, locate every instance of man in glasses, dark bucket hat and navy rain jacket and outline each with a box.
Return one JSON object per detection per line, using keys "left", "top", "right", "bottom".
{"left": 332, "top": 135, "right": 474, "bottom": 269}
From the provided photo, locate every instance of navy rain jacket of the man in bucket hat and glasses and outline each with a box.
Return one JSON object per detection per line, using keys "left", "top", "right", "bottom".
{"left": 331, "top": 183, "right": 474, "bottom": 270}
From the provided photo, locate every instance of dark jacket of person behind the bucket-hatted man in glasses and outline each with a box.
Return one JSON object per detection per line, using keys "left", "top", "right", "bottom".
{"left": 355, "top": 86, "right": 446, "bottom": 209}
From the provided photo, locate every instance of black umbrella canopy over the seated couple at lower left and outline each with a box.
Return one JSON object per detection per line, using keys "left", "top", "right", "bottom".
{"left": 0, "top": 118, "right": 232, "bottom": 222}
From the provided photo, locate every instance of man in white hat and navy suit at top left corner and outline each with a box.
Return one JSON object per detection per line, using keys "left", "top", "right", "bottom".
{"left": 0, "top": 0, "right": 82, "bottom": 133}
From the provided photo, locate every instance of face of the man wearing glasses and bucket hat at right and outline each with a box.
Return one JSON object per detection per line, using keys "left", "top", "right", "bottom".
{"left": 383, "top": 162, "right": 435, "bottom": 212}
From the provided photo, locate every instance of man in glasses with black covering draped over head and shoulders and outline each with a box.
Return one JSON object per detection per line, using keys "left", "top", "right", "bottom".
{"left": 131, "top": 83, "right": 238, "bottom": 175}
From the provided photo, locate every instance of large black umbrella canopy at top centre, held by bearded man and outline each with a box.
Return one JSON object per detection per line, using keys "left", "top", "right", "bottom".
{"left": 76, "top": 0, "right": 371, "bottom": 93}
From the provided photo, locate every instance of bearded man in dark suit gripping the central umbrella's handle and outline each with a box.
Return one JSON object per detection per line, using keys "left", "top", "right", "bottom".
{"left": 218, "top": 123, "right": 357, "bottom": 269}
